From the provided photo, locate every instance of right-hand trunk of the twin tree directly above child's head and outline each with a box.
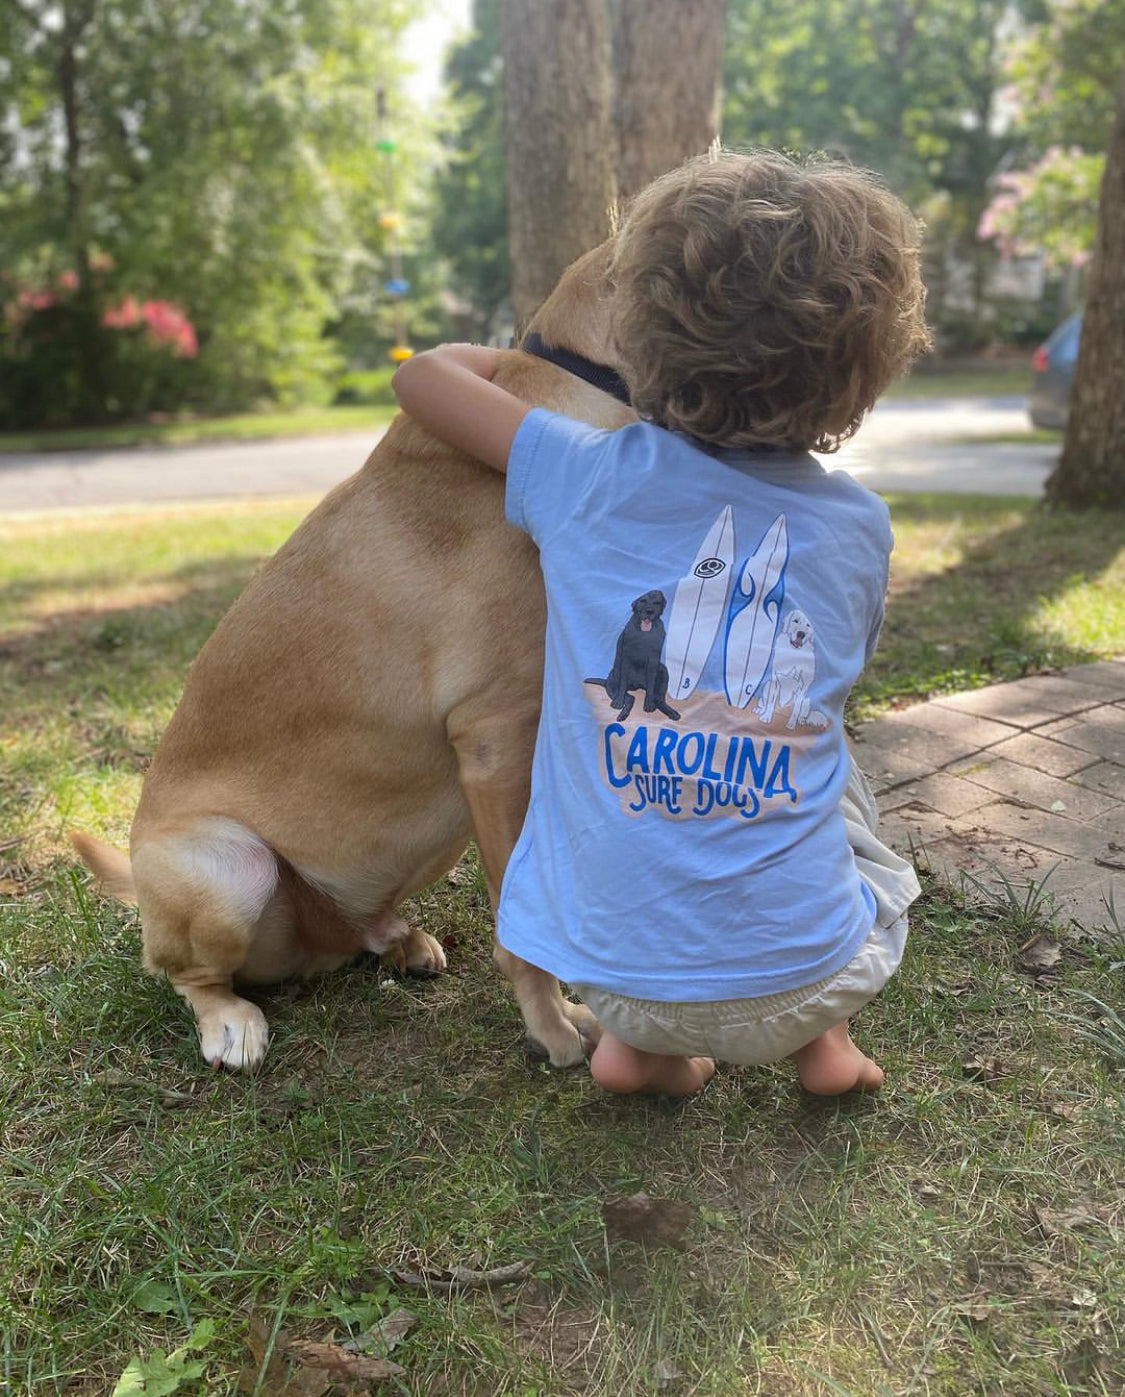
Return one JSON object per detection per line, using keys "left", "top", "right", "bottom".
{"left": 614, "top": 0, "right": 725, "bottom": 200}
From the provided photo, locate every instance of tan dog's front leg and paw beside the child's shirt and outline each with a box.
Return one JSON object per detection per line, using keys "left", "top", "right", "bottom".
{"left": 450, "top": 711, "right": 601, "bottom": 1067}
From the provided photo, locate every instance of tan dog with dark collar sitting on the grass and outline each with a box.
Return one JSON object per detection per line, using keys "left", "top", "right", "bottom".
{"left": 73, "top": 243, "right": 633, "bottom": 1069}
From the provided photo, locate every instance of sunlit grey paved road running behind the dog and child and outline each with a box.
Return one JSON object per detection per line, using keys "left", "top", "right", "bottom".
{"left": 0, "top": 398, "right": 1057, "bottom": 514}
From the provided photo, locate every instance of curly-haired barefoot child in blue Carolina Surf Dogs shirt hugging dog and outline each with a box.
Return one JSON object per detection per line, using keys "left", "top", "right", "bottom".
{"left": 394, "top": 151, "right": 927, "bottom": 1095}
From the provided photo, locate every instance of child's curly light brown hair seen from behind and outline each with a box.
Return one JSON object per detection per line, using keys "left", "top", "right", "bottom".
{"left": 611, "top": 149, "right": 929, "bottom": 451}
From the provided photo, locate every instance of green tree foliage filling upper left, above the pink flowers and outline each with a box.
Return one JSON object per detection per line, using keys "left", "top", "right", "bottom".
{"left": 0, "top": 0, "right": 412, "bottom": 416}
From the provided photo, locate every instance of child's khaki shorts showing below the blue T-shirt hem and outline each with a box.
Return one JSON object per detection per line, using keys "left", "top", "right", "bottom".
{"left": 572, "top": 914, "right": 907, "bottom": 1067}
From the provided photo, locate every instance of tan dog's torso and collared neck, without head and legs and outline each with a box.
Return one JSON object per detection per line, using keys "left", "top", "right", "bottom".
{"left": 133, "top": 352, "right": 625, "bottom": 887}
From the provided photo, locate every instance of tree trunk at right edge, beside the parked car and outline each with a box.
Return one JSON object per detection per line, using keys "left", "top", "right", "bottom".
{"left": 1047, "top": 70, "right": 1125, "bottom": 510}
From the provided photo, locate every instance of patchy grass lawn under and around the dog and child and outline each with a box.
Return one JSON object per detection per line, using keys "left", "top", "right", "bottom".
{"left": 0, "top": 496, "right": 1125, "bottom": 1397}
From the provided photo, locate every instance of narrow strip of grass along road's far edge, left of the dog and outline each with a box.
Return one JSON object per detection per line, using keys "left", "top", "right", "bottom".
{"left": 0, "top": 404, "right": 395, "bottom": 454}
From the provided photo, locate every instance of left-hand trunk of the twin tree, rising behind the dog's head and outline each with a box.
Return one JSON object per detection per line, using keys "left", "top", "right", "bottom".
{"left": 500, "top": 0, "right": 614, "bottom": 326}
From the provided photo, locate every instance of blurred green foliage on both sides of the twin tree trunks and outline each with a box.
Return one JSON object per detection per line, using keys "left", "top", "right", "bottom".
{"left": 436, "top": 0, "right": 1022, "bottom": 338}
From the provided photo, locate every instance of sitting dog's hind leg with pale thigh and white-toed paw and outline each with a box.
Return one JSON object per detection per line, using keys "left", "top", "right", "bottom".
{"left": 133, "top": 819, "right": 285, "bottom": 1070}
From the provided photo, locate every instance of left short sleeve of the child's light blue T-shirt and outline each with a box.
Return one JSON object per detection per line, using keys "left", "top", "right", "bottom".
{"left": 505, "top": 408, "right": 614, "bottom": 546}
